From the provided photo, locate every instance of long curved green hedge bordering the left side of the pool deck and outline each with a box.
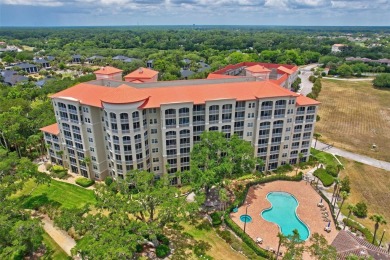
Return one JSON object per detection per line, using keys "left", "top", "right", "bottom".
{"left": 224, "top": 172, "right": 303, "bottom": 259}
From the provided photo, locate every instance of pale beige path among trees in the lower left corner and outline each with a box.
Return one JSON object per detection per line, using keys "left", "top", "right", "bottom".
{"left": 42, "top": 215, "right": 76, "bottom": 256}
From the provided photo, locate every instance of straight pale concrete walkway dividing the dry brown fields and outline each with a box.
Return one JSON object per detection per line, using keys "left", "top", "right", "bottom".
{"left": 311, "top": 140, "right": 390, "bottom": 171}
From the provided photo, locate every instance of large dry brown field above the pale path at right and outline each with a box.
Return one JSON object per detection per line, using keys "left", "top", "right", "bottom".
{"left": 315, "top": 79, "right": 390, "bottom": 162}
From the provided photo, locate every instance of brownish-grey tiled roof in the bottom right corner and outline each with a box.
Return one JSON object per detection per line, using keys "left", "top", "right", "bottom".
{"left": 331, "top": 230, "right": 390, "bottom": 260}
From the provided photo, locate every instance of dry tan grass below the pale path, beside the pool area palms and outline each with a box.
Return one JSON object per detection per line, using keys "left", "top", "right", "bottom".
{"left": 340, "top": 159, "right": 390, "bottom": 245}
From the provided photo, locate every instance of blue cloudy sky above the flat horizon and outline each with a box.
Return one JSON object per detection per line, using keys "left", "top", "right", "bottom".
{"left": 0, "top": 0, "right": 390, "bottom": 27}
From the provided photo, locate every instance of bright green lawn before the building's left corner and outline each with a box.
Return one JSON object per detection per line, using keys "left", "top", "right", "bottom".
{"left": 13, "top": 180, "right": 96, "bottom": 208}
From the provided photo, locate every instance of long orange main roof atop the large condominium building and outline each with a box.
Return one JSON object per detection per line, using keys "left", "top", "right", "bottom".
{"left": 51, "top": 78, "right": 319, "bottom": 108}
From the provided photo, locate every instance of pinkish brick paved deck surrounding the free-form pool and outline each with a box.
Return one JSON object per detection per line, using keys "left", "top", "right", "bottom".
{"left": 230, "top": 181, "right": 338, "bottom": 259}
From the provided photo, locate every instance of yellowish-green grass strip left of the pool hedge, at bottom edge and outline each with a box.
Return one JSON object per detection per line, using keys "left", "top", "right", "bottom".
{"left": 183, "top": 224, "right": 246, "bottom": 260}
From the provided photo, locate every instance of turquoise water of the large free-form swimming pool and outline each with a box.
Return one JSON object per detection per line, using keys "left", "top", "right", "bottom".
{"left": 261, "top": 192, "right": 310, "bottom": 240}
